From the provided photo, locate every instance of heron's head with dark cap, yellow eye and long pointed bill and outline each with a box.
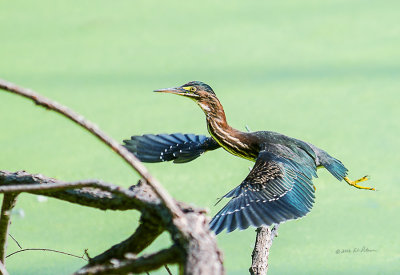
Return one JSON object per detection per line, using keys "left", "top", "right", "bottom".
{"left": 155, "top": 81, "right": 215, "bottom": 101}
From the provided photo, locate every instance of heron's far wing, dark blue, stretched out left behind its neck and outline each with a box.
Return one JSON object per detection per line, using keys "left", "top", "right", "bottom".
{"left": 124, "top": 133, "right": 220, "bottom": 163}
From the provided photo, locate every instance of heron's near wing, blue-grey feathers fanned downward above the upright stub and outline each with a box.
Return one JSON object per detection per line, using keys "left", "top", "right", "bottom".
{"left": 210, "top": 150, "right": 316, "bottom": 234}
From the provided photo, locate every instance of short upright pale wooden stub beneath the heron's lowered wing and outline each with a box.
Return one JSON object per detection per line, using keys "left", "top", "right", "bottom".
{"left": 249, "top": 224, "right": 279, "bottom": 275}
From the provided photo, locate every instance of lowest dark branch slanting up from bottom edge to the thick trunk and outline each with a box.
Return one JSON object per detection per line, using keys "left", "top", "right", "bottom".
{"left": 75, "top": 245, "right": 181, "bottom": 275}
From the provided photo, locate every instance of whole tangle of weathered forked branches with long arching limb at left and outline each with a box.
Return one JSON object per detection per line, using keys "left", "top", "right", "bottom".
{"left": 0, "top": 79, "right": 224, "bottom": 274}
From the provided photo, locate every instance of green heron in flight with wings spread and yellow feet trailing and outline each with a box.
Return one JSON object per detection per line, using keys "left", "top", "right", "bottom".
{"left": 124, "top": 81, "right": 375, "bottom": 234}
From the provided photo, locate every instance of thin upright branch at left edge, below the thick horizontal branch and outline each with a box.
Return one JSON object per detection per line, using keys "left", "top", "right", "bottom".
{"left": 0, "top": 193, "right": 18, "bottom": 266}
